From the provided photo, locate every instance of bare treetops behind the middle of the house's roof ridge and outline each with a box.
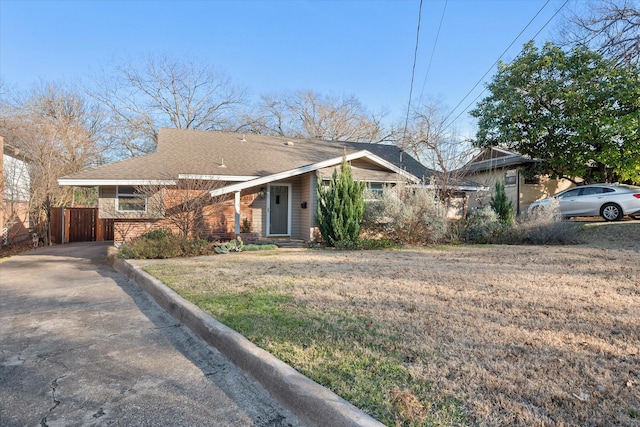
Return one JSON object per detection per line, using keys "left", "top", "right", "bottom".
{"left": 240, "top": 90, "right": 389, "bottom": 142}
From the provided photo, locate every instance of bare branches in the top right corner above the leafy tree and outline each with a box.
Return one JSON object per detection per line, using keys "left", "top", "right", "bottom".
{"left": 559, "top": 0, "right": 640, "bottom": 66}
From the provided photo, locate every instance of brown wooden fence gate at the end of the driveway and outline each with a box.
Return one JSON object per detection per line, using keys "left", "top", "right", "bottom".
{"left": 51, "top": 208, "right": 113, "bottom": 244}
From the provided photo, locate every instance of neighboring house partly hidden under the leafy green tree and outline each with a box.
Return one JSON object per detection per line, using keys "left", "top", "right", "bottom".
{"left": 457, "top": 147, "right": 573, "bottom": 214}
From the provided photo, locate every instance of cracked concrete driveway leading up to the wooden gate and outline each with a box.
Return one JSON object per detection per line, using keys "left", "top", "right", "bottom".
{"left": 0, "top": 243, "right": 299, "bottom": 426}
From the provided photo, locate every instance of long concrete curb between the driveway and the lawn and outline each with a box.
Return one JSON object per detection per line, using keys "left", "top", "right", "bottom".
{"left": 108, "top": 255, "right": 383, "bottom": 427}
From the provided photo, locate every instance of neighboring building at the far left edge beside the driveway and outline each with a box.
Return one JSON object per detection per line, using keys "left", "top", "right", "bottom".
{"left": 0, "top": 136, "right": 31, "bottom": 245}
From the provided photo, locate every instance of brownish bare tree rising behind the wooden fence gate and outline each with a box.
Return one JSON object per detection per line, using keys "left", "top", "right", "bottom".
{"left": 0, "top": 83, "right": 107, "bottom": 243}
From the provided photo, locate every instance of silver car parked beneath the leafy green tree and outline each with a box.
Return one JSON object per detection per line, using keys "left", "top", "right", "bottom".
{"left": 529, "top": 184, "right": 640, "bottom": 221}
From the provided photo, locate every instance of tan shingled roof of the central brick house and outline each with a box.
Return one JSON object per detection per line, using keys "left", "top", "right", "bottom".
{"left": 59, "top": 128, "right": 433, "bottom": 185}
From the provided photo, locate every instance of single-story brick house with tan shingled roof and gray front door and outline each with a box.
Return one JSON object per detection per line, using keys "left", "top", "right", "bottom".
{"left": 58, "top": 129, "right": 432, "bottom": 245}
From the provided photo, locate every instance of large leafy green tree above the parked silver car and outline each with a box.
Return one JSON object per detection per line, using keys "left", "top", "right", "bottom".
{"left": 471, "top": 42, "right": 640, "bottom": 186}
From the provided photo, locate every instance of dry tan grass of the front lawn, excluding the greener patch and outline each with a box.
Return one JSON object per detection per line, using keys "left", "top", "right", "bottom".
{"left": 138, "top": 221, "right": 640, "bottom": 426}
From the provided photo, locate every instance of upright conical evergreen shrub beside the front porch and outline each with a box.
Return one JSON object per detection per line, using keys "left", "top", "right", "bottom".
{"left": 317, "top": 157, "right": 365, "bottom": 246}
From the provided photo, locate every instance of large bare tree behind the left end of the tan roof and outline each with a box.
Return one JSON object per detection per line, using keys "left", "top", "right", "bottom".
{"left": 90, "top": 55, "right": 245, "bottom": 156}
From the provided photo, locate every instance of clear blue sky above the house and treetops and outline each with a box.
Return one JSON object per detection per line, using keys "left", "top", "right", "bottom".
{"left": 0, "top": 0, "right": 575, "bottom": 138}
